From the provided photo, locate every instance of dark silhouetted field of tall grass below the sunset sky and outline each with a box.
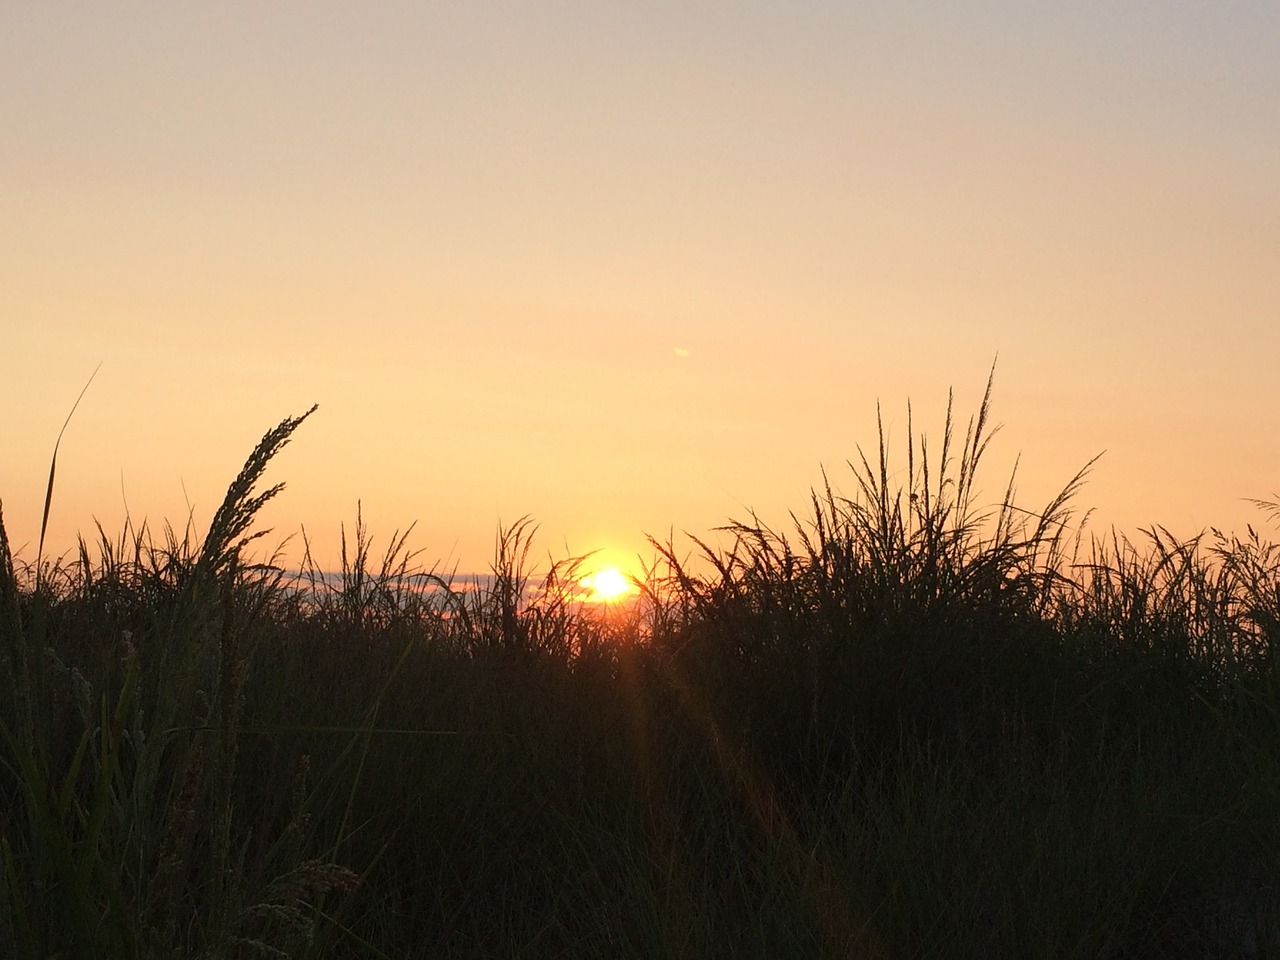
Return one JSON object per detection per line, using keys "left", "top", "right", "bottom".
{"left": 0, "top": 385, "right": 1280, "bottom": 959}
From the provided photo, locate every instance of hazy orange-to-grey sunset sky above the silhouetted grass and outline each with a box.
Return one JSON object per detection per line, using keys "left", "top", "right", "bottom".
{"left": 0, "top": 0, "right": 1280, "bottom": 572}
